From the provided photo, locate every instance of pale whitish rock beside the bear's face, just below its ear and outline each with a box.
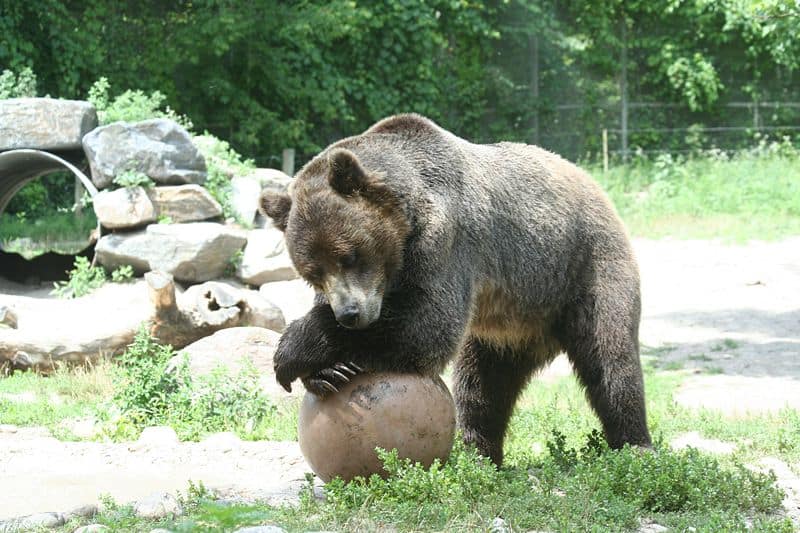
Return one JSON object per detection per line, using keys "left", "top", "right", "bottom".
{"left": 241, "top": 228, "right": 298, "bottom": 285}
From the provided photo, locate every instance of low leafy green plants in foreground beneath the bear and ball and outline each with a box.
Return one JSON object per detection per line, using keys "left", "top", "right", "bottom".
{"left": 288, "top": 432, "right": 791, "bottom": 531}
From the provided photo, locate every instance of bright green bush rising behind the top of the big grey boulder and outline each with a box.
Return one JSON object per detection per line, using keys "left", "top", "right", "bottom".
{"left": 87, "top": 77, "right": 192, "bottom": 130}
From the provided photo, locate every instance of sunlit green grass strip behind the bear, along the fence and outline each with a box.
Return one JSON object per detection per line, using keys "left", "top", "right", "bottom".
{"left": 591, "top": 150, "right": 800, "bottom": 242}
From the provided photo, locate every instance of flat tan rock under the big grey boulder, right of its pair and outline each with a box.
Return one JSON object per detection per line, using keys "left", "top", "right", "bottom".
{"left": 147, "top": 185, "right": 222, "bottom": 223}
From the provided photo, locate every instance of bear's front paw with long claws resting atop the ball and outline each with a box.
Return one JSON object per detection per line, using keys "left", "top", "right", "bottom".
{"left": 273, "top": 304, "right": 363, "bottom": 396}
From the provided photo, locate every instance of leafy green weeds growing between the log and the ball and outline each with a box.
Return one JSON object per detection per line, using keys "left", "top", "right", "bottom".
{"left": 101, "top": 326, "right": 285, "bottom": 439}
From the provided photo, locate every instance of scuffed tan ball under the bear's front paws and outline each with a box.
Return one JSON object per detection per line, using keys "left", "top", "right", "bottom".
{"left": 298, "top": 374, "right": 456, "bottom": 482}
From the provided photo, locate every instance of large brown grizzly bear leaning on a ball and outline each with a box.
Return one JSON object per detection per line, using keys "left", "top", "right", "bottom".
{"left": 260, "top": 114, "right": 651, "bottom": 465}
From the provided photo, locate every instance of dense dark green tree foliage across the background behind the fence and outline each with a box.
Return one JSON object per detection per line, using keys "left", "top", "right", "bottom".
{"left": 0, "top": 0, "right": 800, "bottom": 165}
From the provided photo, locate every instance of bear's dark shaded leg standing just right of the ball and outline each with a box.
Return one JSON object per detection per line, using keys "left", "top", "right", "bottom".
{"left": 453, "top": 337, "right": 540, "bottom": 466}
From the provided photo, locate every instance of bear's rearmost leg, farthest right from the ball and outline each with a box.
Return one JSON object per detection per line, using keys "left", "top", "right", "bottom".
{"left": 561, "top": 286, "right": 652, "bottom": 448}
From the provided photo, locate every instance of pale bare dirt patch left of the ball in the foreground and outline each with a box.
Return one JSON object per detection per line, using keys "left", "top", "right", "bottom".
{"left": 0, "top": 426, "right": 310, "bottom": 520}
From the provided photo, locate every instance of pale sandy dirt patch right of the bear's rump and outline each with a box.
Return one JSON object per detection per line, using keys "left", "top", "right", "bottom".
{"left": 635, "top": 237, "right": 800, "bottom": 416}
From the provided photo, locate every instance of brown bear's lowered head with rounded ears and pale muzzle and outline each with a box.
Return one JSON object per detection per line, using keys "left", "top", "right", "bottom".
{"left": 259, "top": 148, "right": 409, "bottom": 329}
